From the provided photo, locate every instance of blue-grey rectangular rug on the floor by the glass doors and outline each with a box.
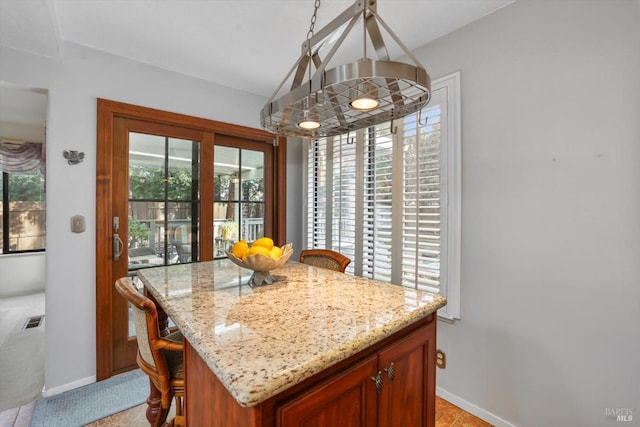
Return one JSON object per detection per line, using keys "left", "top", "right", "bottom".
{"left": 31, "top": 369, "right": 149, "bottom": 427}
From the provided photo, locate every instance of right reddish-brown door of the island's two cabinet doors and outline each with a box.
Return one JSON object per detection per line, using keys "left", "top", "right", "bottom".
{"left": 378, "top": 321, "right": 436, "bottom": 427}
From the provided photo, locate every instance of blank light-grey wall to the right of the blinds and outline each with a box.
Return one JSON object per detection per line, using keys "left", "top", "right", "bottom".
{"left": 417, "top": 0, "right": 640, "bottom": 427}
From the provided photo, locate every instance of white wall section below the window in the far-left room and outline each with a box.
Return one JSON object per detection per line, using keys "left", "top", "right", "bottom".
{"left": 0, "top": 252, "right": 46, "bottom": 298}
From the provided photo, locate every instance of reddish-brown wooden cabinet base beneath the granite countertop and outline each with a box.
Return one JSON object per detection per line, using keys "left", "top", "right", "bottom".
{"left": 185, "top": 315, "right": 436, "bottom": 427}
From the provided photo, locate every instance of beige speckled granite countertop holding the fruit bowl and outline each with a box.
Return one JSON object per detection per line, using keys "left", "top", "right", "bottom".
{"left": 137, "top": 259, "right": 446, "bottom": 407}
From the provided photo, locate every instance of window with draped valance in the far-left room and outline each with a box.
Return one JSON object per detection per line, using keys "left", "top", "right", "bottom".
{"left": 0, "top": 142, "right": 46, "bottom": 254}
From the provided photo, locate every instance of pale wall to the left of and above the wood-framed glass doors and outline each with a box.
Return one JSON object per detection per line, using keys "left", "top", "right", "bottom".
{"left": 0, "top": 44, "right": 266, "bottom": 393}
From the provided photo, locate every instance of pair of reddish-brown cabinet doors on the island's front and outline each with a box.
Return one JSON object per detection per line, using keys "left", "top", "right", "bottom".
{"left": 276, "top": 322, "right": 435, "bottom": 427}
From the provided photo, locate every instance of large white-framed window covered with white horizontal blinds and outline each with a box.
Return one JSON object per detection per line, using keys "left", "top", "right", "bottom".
{"left": 304, "top": 73, "right": 461, "bottom": 319}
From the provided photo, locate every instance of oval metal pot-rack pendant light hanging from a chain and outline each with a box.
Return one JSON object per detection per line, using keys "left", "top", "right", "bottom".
{"left": 260, "top": 0, "right": 431, "bottom": 138}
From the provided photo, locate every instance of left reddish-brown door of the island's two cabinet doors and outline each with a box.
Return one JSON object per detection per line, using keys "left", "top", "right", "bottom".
{"left": 276, "top": 356, "right": 378, "bottom": 427}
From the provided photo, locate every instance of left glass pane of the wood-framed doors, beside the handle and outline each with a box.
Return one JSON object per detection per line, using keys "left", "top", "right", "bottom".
{"left": 123, "top": 132, "right": 195, "bottom": 336}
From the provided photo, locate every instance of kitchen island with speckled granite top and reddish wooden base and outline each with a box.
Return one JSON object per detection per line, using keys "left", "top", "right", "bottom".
{"left": 138, "top": 259, "right": 446, "bottom": 427}
